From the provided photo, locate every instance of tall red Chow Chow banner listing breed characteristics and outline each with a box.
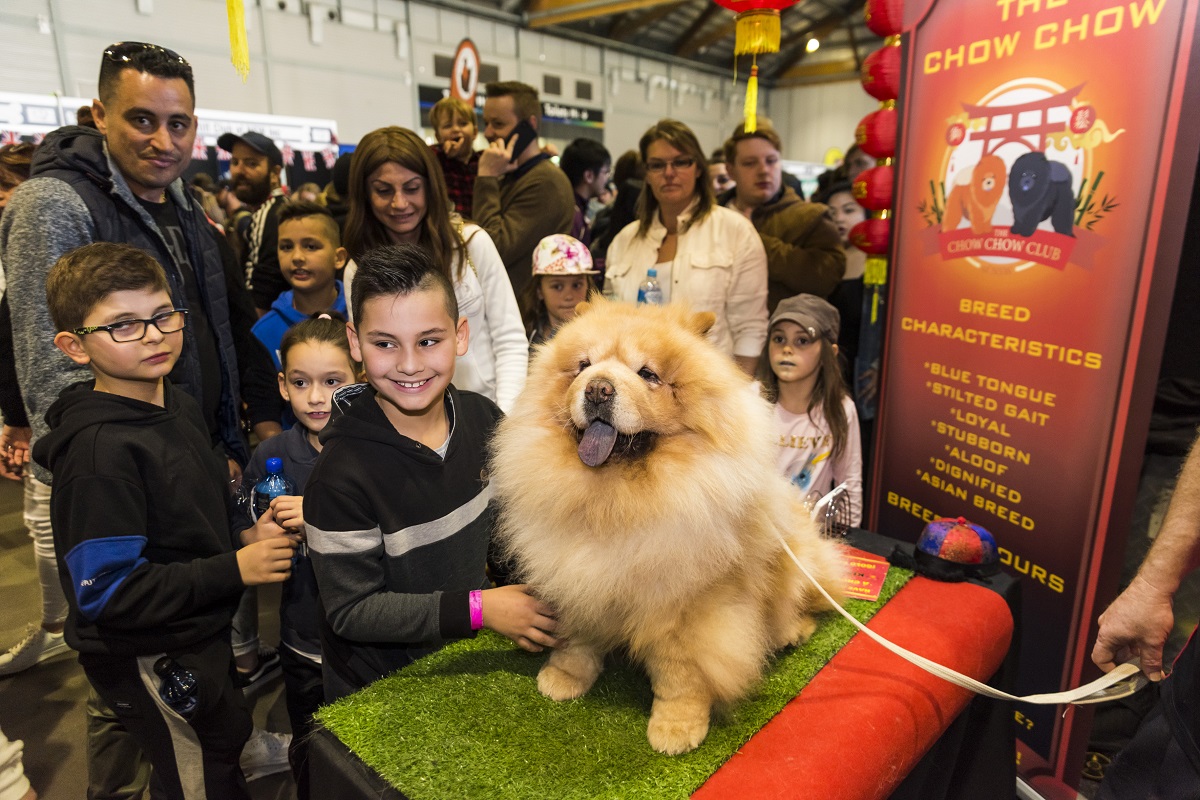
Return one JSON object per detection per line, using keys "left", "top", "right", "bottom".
{"left": 870, "top": 0, "right": 1196, "bottom": 780}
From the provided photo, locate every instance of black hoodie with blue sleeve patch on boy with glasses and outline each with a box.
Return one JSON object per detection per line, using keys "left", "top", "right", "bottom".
{"left": 34, "top": 381, "right": 245, "bottom": 656}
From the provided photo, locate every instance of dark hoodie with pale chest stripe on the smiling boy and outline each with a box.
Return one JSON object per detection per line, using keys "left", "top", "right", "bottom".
{"left": 304, "top": 384, "right": 500, "bottom": 699}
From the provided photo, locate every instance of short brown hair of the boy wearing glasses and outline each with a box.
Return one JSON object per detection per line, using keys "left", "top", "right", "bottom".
{"left": 46, "top": 241, "right": 170, "bottom": 331}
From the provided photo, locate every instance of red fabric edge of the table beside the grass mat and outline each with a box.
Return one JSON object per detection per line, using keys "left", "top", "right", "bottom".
{"left": 692, "top": 576, "right": 1013, "bottom": 800}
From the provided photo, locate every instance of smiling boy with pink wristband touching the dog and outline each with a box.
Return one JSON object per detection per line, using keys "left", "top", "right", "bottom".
{"left": 304, "top": 243, "right": 557, "bottom": 702}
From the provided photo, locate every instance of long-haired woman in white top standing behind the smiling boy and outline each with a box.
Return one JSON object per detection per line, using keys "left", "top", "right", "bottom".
{"left": 344, "top": 126, "right": 528, "bottom": 411}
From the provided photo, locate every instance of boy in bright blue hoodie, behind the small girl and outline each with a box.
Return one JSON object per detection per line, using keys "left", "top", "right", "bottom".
{"left": 251, "top": 200, "right": 347, "bottom": 369}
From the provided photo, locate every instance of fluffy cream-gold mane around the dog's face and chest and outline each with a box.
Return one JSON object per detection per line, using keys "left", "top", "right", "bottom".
{"left": 491, "top": 300, "right": 835, "bottom": 649}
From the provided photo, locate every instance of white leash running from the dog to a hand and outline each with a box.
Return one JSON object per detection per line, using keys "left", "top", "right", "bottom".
{"left": 779, "top": 537, "right": 1148, "bottom": 705}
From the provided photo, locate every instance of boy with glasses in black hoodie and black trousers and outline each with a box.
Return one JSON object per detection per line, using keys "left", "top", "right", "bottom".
{"left": 34, "top": 242, "right": 294, "bottom": 799}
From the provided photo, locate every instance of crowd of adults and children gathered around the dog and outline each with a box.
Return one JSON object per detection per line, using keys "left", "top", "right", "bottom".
{"left": 0, "top": 42, "right": 878, "bottom": 800}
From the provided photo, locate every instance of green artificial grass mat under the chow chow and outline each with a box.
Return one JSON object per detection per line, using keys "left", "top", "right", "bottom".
{"left": 317, "top": 567, "right": 912, "bottom": 800}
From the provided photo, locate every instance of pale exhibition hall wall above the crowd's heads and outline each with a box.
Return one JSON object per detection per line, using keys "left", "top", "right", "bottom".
{"left": 0, "top": 0, "right": 876, "bottom": 162}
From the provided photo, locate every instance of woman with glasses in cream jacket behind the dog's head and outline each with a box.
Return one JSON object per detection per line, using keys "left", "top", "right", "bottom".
{"left": 605, "top": 120, "right": 767, "bottom": 375}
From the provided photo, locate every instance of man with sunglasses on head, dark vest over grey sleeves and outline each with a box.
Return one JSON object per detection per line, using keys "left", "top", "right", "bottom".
{"left": 0, "top": 42, "right": 281, "bottom": 796}
